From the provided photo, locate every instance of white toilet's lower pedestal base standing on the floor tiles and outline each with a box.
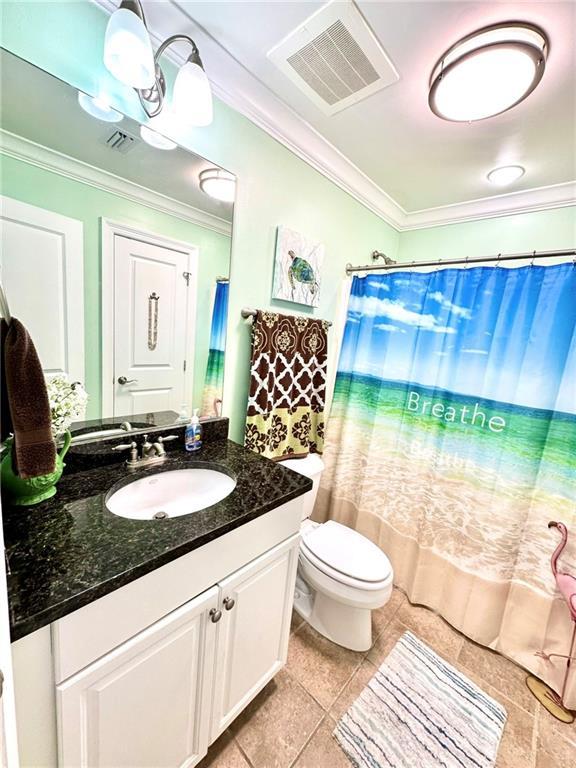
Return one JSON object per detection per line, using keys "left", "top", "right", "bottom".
{"left": 294, "top": 580, "right": 372, "bottom": 651}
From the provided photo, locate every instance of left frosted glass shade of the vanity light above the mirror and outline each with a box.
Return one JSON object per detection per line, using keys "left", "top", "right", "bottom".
{"left": 104, "top": 7, "right": 155, "bottom": 89}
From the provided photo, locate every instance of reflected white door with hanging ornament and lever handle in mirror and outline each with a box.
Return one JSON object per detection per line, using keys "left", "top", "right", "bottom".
{"left": 114, "top": 235, "right": 191, "bottom": 416}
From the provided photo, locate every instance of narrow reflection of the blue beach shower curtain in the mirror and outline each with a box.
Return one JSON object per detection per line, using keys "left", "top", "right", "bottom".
{"left": 201, "top": 280, "right": 229, "bottom": 416}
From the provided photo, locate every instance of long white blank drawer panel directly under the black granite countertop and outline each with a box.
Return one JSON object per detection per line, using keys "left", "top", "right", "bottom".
{"left": 52, "top": 497, "right": 303, "bottom": 683}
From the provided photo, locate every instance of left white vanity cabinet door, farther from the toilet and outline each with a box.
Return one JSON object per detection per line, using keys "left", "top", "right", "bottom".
{"left": 57, "top": 587, "right": 218, "bottom": 768}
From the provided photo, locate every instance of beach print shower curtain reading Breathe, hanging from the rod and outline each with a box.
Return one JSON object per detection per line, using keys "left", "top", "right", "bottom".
{"left": 315, "top": 263, "right": 576, "bottom": 708}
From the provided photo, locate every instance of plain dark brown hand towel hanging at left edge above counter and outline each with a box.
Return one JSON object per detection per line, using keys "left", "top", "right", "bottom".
{"left": 2, "top": 317, "right": 56, "bottom": 478}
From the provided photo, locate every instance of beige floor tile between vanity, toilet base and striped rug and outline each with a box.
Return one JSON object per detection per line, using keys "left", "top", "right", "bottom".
{"left": 286, "top": 623, "right": 364, "bottom": 710}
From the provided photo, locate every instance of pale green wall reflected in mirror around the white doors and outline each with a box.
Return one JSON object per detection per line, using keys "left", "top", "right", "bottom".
{"left": 0, "top": 155, "right": 230, "bottom": 418}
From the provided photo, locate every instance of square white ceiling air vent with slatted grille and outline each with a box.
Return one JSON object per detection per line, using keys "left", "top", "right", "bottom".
{"left": 268, "top": 0, "right": 399, "bottom": 115}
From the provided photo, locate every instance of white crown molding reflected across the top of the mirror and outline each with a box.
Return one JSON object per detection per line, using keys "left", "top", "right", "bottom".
{"left": 0, "top": 130, "right": 232, "bottom": 237}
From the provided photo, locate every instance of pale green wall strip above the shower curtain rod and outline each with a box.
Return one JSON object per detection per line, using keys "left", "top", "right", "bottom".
{"left": 398, "top": 206, "right": 576, "bottom": 261}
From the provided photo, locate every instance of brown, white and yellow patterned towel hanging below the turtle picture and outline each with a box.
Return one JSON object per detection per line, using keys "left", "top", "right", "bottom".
{"left": 245, "top": 311, "right": 328, "bottom": 459}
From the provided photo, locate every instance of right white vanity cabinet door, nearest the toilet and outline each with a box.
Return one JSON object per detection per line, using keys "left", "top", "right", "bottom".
{"left": 210, "top": 534, "right": 300, "bottom": 742}
